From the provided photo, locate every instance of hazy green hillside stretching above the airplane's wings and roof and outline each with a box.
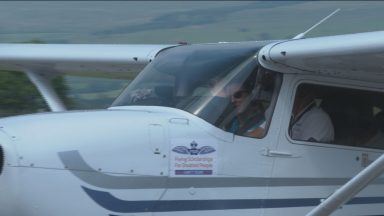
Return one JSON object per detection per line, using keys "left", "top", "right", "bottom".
{"left": 0, "top": 1, "right": 384, "bottom": 43}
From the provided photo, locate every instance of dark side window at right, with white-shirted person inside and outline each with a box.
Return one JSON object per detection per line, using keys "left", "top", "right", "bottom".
{"left": 289, "top": 84, "right": 384, "bottom": 149}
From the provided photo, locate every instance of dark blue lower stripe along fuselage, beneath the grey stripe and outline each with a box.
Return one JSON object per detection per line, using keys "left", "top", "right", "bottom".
{"left": 82, "top": 186, "right": 384, "bottom": 213}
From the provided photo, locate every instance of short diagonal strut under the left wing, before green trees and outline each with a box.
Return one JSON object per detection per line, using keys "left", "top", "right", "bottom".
{"left": 25, "top": 70, "right": 66, "bottom": 112}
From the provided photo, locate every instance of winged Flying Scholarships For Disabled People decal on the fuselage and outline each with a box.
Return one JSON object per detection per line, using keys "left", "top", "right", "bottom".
{"left": 171, "top": 138, "right": 218, "bottom": 176}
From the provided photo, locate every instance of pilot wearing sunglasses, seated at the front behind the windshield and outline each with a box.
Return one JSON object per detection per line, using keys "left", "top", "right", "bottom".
{"left": 226, "top": 82, "right": 265, "bottom": 138}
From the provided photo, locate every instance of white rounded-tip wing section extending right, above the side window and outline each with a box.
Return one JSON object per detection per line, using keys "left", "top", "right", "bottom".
{"left": 259, "top": 31, "right": 384, "bottom": 82}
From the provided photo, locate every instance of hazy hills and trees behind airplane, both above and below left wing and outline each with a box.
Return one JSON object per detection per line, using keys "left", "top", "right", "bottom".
{"left": 0, "top": 1, "right": 384, "bottom": 116}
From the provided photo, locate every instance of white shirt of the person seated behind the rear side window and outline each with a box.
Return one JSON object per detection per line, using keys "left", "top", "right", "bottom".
{"left": 291, "top": 106, "right": 334, "bottom": 143}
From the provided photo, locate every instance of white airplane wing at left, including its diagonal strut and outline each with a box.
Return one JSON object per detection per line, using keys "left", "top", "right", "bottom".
{"left": 0, "top": 44, "right": 175, "bottom": 111}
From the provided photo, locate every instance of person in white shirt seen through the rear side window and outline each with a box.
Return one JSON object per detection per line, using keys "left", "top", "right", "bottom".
{"left": 289, "top": 85, "right": 334, "bottom": 143}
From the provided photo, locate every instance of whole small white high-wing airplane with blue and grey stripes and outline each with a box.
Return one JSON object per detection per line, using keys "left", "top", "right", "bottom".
{"left": 0, "top": 10, "right": 384, "bottom": 216}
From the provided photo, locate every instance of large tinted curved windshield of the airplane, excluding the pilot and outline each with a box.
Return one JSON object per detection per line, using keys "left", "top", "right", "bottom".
{"left": 112, "top": 43, "right": 280, "bottom": 138}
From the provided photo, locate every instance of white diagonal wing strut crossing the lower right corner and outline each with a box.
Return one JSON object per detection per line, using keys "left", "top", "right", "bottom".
{"left": 306, "top": 154, "right": 384, "bottom": 216}
